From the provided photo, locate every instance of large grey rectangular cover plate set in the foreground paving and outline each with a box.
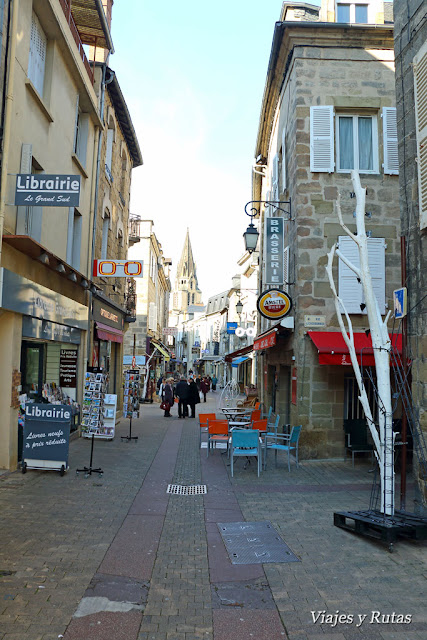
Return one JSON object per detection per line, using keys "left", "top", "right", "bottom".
{"left": 218, "top": 520, "right": 300, "bottom": 564}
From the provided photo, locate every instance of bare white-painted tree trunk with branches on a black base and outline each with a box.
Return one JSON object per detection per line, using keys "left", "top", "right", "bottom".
{"left": 326, "top": 171, "right": 394, "bottom": 516}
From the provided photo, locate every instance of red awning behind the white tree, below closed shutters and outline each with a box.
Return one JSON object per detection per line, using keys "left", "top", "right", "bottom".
{"left": 308, "top": 331, "right": 402, "bottom": 367}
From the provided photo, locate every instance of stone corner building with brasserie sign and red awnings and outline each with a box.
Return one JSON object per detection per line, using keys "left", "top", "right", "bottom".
{"left": 253, "top": 0, "right": 400, "bottom": 458}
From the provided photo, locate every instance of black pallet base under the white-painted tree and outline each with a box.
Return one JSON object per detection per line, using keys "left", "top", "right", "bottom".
{"left": 334, "top": 510, "right": 427, "bottom": 551}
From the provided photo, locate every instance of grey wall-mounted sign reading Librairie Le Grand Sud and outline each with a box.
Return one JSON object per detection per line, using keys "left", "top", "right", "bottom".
{"left": 15, "top": 173, "right": 81, "bottom": 207}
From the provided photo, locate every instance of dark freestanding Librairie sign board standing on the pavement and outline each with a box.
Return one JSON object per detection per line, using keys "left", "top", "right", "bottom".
{"left": 22, "top": 402, "right": 72, "bottom": 469}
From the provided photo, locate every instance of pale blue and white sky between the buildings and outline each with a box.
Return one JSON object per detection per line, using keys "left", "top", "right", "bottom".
{"left": 109, "top": 0, "right": 318, "bottom": 303}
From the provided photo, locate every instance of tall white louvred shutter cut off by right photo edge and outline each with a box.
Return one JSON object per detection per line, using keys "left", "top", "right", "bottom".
{"left": 414, "top": 42, "right": 427, "bottom": 229}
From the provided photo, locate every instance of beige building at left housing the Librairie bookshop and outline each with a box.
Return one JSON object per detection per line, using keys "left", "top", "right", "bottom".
{"left": 0, "top": 0, "right": 113, "bottom": 469}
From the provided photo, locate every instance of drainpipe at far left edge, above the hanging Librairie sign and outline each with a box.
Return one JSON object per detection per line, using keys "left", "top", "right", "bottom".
{"left": 0, "top": 0, "right": 19, "bottom": 265}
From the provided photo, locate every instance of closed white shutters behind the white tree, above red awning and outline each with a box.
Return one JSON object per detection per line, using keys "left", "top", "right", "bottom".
{"left": 338, "top": 236, "right": 386, "bottom": 315}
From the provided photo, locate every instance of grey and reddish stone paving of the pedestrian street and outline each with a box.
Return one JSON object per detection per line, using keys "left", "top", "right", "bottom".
{"left": 0, "top": 394, "right": 427, "bottom": 640}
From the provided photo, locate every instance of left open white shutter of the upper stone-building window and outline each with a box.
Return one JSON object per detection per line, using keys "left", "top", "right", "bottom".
{"left": 310, "top": 106, "right": 335, "bottom": 173}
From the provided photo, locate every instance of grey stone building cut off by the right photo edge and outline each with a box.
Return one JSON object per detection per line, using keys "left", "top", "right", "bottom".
{"left": 394, "top": 0, "right": 427, "bottom": 509}
